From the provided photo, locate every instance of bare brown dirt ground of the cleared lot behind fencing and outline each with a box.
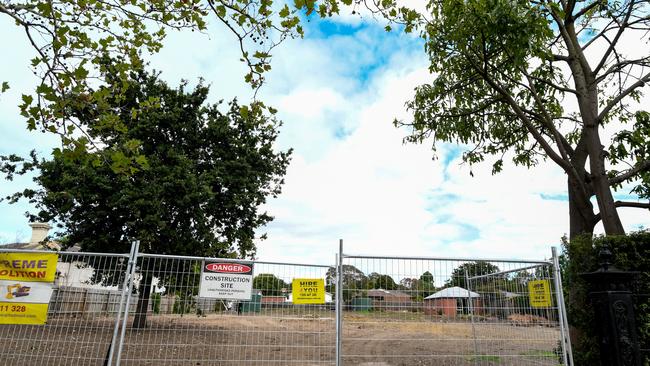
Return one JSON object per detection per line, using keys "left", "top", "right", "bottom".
{"left": 0, "top": 312, "right": 559, "bottom": 366}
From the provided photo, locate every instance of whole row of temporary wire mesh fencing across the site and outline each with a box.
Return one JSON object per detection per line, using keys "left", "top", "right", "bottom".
{"left": 0, "top": 242, "right": 570, "bottom": 366}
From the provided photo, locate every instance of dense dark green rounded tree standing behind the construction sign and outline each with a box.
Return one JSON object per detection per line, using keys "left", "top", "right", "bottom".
{"left": 0, "top": 65, "right": 290, "bottom": 326}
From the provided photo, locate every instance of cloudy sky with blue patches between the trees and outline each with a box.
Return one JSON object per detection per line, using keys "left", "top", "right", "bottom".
{"left": 0, "top": 7, "right": 650, "bottom": 264}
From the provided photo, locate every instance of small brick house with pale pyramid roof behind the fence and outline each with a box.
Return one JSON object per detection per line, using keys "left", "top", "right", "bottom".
{"left": 424, "top": 286, "right": 483, "bottom": 318}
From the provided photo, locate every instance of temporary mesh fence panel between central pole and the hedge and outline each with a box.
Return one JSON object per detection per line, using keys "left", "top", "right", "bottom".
{"left": 340, "top": 254, "right": 567, "bottom": 366}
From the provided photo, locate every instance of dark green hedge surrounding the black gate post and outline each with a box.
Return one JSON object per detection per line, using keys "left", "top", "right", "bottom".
{"left": 560, "top": 230, "right": 650, "bottom": 366}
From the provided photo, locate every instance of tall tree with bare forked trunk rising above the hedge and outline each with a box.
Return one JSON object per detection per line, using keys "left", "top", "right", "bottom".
{"left": 396, "top": 0, "right": 650, "bottom": 237}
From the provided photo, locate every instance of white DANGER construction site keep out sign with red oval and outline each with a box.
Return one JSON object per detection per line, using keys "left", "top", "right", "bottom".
{"left": 199, "top": 261, "right": 253, "bottom": 300}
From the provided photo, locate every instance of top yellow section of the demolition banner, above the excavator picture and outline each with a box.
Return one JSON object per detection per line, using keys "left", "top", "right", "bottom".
{"left": 0, "top": 252, "right": 58, "bottom": 282}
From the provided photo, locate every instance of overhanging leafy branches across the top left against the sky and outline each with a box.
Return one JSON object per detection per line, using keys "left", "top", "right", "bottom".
{"left": 0, "top": 0, "right": 309, "bottom": 174}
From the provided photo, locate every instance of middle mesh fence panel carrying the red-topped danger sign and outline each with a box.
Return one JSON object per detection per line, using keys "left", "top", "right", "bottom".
{"left": 119, "top": 254, "right": 336, "bottom": 366}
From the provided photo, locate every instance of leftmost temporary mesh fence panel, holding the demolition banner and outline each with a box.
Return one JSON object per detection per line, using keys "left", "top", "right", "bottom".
{"left": 0, "top": 250, "right": 129, "bottom": 366}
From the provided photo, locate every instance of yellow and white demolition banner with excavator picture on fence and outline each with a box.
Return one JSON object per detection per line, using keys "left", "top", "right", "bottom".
{"left": 0, "top": 252, "right": 58, "bottom": 324}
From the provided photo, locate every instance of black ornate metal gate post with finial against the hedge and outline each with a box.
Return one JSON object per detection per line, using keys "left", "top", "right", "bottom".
{"left": 581, "top": 247, "right": 641, "bottom": 366}
